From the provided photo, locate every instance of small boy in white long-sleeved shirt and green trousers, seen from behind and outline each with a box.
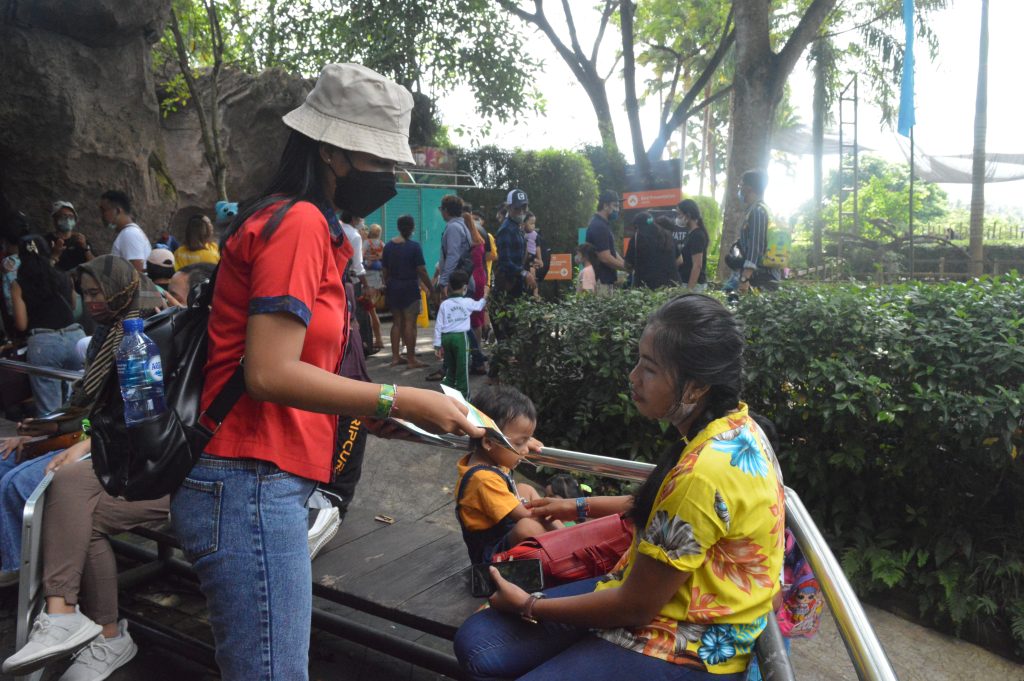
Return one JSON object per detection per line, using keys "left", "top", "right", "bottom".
{"left": 434, "top": 269, "right": 487, "bottom": 399}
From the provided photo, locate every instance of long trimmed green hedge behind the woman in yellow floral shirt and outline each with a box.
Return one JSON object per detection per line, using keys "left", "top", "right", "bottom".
{"left": 497, "top": 279, "right": 1024, "bottom": 653}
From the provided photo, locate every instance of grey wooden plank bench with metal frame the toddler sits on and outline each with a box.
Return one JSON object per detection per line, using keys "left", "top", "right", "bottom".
{"left": 17, "top": 477, "right": 793, "bottom": 681}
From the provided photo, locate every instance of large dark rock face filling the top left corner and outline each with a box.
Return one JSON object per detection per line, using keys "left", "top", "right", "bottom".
{"left": 0, "top": 0, "right": 177, "bottom": 250}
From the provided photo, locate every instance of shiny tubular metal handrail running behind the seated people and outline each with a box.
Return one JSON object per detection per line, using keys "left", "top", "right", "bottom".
{"left": 0, "top": 358, "right": 898, "bottom": 681}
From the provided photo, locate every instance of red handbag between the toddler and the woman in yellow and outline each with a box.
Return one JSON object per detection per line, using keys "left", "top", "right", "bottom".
{"left": 492, "top": 515, "right": 633, "bottom": 586}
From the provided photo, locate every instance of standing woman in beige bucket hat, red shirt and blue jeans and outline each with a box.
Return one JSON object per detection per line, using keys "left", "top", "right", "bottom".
{"left": 171, "top": 63, "right": 483, "bottom": 681}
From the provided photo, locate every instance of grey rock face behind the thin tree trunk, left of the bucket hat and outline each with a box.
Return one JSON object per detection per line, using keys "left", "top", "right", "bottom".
{"left": 162, "top": 70, "right": 313, "bottom": 235}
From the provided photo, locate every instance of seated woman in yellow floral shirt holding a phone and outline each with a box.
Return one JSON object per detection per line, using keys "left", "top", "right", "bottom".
{"left": 455, "top": 295, "right": 784, "bottom": 681}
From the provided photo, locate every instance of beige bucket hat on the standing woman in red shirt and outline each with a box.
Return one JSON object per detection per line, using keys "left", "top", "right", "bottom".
{"left": 282, "top": 63, "right": 414, "bottom": 164}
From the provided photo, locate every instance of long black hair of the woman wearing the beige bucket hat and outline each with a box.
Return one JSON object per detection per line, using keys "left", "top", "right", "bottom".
{"left": 220, "top": 130, "right": 330, "bottom": 244}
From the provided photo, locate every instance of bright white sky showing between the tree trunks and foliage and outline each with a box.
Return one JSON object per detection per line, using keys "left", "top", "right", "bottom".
{"left": 439, "top": 0, "right": 1024, "bottom": 216}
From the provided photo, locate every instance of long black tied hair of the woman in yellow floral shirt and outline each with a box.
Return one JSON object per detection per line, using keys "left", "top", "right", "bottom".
{"left": 629, "top": 294, "right": 743, "bottom": 527}
